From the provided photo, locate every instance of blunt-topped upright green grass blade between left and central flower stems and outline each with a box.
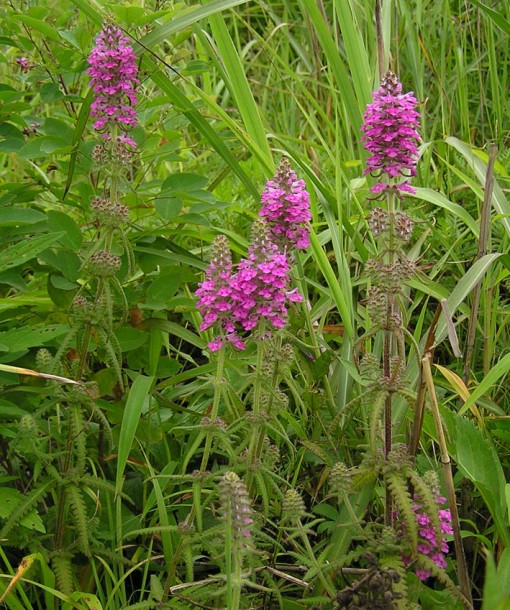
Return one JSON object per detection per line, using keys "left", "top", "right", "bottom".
{"left": 115, "top": 375, "right": 153, "bottom": 493}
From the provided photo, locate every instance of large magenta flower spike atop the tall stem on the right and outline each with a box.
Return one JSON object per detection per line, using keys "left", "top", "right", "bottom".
{"left": 361, "top": 72, "right": 420, "bottom": 194}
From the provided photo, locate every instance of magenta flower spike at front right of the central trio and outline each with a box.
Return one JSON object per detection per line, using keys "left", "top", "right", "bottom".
{"left": 231, "top": 219, "right": 302, "bottom": 330}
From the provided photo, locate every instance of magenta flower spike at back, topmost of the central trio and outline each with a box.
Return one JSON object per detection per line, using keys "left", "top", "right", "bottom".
{"left": 259, "top": 157, "right": 312, "bottom": 251}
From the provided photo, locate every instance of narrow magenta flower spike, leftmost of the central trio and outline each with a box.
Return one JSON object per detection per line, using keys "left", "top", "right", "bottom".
{"left": 195, "top": 235, "right": 245, "bottom": 352}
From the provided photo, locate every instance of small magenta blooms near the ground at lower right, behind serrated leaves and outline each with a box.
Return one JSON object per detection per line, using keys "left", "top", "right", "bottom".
{"left": 404, "top": 495, "right": 453, "bottom": 581}
